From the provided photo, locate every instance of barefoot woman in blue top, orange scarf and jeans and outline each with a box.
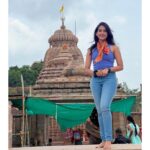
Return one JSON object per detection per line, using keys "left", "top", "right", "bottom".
{"left": 85, "top": 22, "right": 123, "bottom": 150}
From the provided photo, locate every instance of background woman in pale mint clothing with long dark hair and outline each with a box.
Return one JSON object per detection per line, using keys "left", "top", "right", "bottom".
{"left": 127, "top": 116, "right": 141, "bottom": 144}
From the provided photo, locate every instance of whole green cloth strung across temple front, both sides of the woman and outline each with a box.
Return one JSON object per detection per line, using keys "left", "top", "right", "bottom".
{"left": 9, "top": 96, "right": 136, "bottom": 131}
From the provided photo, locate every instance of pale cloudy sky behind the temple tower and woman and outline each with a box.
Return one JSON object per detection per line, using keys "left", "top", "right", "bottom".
{"left": 9, "top": 0, "right": 141, "bottom": 89}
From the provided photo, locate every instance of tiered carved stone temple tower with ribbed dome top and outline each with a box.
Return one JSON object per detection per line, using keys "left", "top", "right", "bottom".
{"left": 34, "top": 18, "right": 92, "bottom": 102}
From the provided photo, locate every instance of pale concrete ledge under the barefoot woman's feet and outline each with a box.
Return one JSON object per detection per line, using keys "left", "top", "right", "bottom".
{"left": 9, "top": 144, "right": 141, "bottom": 150}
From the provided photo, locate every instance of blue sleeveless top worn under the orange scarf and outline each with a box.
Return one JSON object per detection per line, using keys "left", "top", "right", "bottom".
{"left": 92, "top": 45, "right": 115, "bottom": 70}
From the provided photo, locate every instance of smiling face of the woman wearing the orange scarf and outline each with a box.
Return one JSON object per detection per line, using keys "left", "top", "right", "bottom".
{"left": 96, "top": 25, "right": 107, "bottom": 41}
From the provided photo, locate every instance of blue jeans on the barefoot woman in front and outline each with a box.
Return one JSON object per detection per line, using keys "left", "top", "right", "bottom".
{"left": 90, "top": 73, "right": 117, "bottom": 141}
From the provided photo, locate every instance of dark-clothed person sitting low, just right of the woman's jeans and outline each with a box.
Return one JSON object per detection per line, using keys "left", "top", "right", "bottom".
{"left": 113, "top": 128, "right": 131, "bottom": 144}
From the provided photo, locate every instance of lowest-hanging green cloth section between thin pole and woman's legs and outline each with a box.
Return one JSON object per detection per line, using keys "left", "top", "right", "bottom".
{"left": 56, "top": 103, "right": 94, "bottom": 130}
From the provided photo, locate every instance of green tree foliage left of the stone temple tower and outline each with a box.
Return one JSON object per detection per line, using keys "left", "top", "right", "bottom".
{"left": 9, "top": 61, "right": 43, "bottom": 87}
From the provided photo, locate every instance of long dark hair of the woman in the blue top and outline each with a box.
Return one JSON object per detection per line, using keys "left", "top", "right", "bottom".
{"left": 90, "top": 22, "right": 115, "bottom": 51}
